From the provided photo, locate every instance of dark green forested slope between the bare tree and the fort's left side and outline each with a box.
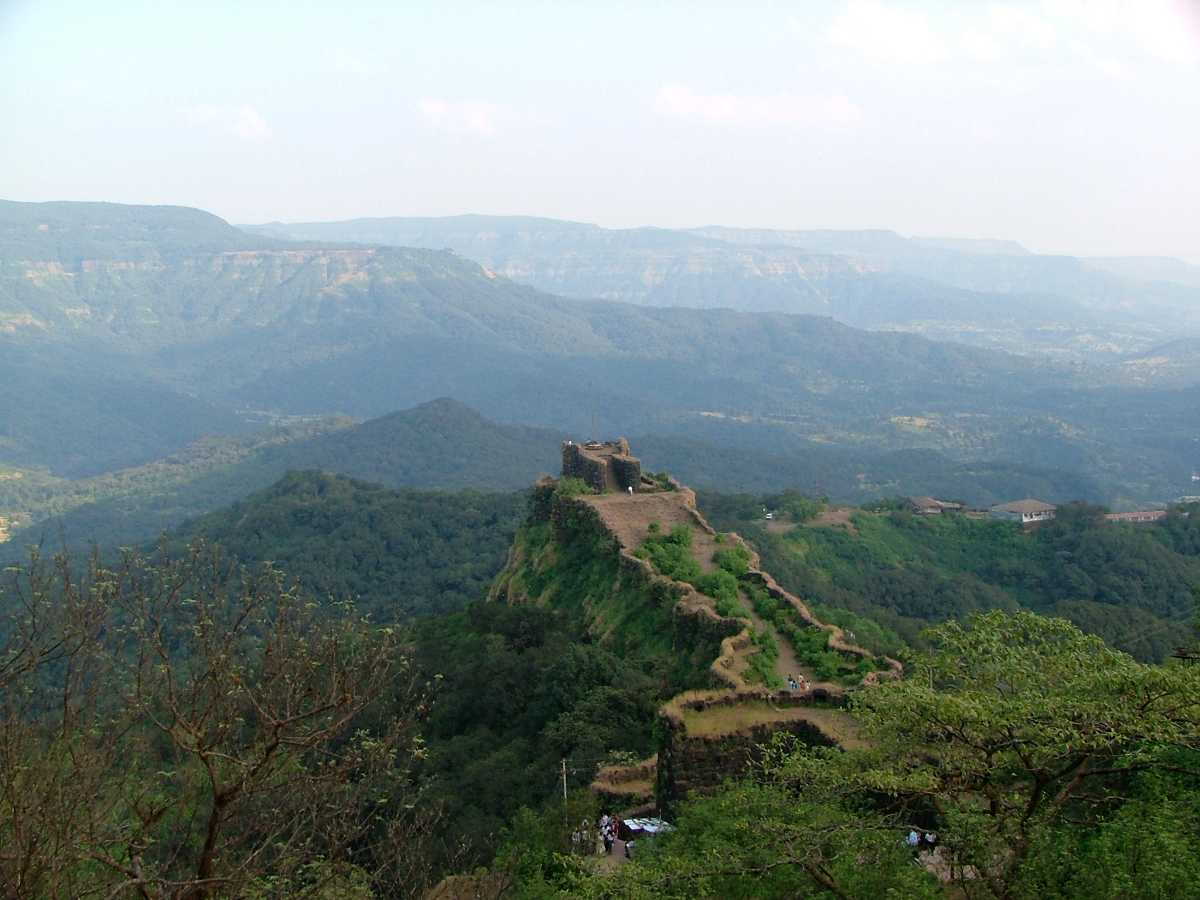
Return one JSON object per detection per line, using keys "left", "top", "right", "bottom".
{"left": 164, "top": 472, "right": 700, "bottom": 883}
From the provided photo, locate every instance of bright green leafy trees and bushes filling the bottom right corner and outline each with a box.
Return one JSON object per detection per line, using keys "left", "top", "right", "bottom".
{"left": 562, "top": 612, "right": 1200, "bottom": 900}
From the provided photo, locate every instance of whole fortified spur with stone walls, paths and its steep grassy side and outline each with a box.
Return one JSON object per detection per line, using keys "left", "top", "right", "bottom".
{"left": 491, "top": 439, "right": 902, "bottom": 814}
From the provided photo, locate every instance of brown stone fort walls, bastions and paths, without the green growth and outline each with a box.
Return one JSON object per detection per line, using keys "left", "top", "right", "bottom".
{"left": 492, "top": 440, "right": 902, "bottom": 814}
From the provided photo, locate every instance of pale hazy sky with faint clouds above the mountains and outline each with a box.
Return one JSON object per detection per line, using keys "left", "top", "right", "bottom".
{"left": 0, "top": 0, "right": 1200, "bottom": 263}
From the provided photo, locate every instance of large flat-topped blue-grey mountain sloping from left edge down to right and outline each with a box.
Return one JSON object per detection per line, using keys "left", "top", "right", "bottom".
{"left": 0, "top": 203, "right": 1198, "bottom": 515}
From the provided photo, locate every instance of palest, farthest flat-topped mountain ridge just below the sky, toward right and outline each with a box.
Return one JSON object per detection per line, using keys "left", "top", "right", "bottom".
{"left": 244, "top": 215, "right": 1200, "bottom": 358}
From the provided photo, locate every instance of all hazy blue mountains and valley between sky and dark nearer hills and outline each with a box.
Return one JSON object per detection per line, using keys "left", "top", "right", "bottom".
{"left": 0, "top": 203, "right": 1200, "bottom": 556}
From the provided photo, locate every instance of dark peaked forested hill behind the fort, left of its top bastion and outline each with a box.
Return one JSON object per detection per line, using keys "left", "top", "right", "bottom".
{"left": 0, "top": 400, "right": 559, "bottom": 559}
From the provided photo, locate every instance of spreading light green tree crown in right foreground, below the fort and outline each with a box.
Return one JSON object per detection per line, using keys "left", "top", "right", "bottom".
{"left": 780, "top": 612, "right": 1200, "bottom": 898}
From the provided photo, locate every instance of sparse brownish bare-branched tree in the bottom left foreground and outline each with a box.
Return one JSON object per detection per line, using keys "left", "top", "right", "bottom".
{"left": 0, "top": 546, "right": 433, "bottom": 899}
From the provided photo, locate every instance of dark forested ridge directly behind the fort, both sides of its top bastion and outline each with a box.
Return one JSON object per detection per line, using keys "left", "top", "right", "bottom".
{"left": 0, "top": 398, "right": 1104, "bottom": 559}
